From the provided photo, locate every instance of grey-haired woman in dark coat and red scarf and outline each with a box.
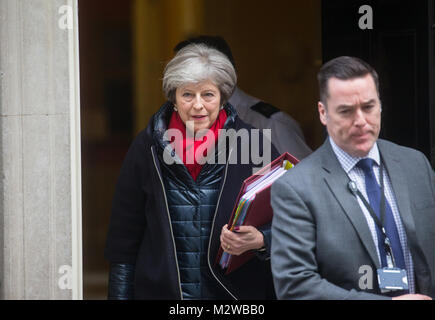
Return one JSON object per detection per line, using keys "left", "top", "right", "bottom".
{"left": 105, "top": 44, "right": 278, "bottom": 299}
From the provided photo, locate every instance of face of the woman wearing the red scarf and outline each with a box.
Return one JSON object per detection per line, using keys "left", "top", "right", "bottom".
{"left": 175, "top": 80, "right": 221, "bottom": 133}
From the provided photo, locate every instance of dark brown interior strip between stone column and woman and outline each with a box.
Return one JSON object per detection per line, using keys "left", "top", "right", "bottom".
{"left": 79, "top": 0, "right": 134, "bottom": 299}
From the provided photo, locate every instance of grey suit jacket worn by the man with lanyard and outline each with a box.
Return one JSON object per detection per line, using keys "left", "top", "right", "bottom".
{"left": 271, "top": 139, "right": 435, "bottom": 299}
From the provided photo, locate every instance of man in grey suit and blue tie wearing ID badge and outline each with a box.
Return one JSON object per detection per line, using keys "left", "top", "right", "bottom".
{"left": 271, "top": 57, "right": 435, "bottom": 299}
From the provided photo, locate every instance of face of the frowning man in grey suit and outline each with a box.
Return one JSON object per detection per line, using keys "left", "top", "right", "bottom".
{"left": 318, "top": 74, "right": 381, "bottom": 157}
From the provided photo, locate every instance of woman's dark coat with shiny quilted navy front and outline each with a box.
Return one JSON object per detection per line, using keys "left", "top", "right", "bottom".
{"left": 105, "top": 103, "right": 278, "bottom": 300}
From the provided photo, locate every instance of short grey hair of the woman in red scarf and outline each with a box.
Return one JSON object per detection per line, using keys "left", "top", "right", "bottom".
{"left": 163, "top": 43, "right": 237, "bottom": 104}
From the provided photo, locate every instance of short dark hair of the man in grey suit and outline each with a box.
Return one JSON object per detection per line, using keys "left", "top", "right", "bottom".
{"left": 317, "top": 56, "right": 380, "bottom": 105}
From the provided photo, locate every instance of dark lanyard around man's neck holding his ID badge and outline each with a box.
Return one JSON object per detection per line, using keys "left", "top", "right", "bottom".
{"left": 349, "top": 160, "right": 396, "bottom": 268}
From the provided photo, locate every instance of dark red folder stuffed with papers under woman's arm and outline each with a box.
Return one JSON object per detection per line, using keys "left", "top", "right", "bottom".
{"left": 218, "top": 152, "right": 299, "bottom": 273}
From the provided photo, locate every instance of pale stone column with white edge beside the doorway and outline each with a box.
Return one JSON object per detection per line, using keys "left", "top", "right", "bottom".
{"left": 0, "top": 0, "right": 82, "bottom": 299}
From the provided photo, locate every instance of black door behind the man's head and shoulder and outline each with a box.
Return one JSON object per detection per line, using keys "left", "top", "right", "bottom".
{"left": 322, "top": 0, "right": 435, "bottom": 167}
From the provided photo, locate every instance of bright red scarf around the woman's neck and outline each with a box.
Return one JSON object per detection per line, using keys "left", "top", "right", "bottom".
{"left": 168, "top": 109, "right": 227, "bottom": 181}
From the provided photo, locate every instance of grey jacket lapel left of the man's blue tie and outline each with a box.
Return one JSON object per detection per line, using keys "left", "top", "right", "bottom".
{"left": 322, "top": 139, "right": 380, "bottom": 268}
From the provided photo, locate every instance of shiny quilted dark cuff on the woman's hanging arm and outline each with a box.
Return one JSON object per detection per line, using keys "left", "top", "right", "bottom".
{"left": 107, "top": 263, "right": 135, "bottom": 300}
